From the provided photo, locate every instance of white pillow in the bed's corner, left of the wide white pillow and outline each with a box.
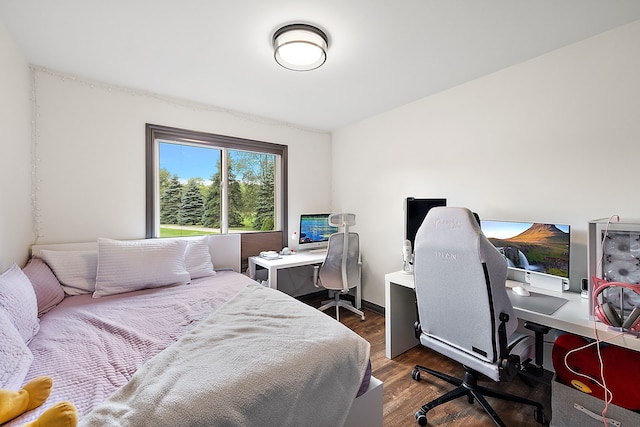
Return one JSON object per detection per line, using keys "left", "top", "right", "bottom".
{"left": 40, "top": 249, "right": 98, "bottom": 295}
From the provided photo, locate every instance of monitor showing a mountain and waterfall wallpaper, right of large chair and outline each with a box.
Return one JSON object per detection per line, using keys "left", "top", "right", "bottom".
{"left": 480, "top": 220, "right": 571, "bottom": 290}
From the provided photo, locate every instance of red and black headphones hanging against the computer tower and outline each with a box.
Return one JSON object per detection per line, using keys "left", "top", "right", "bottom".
{"left": 592, "top": 277, "right": 640, "bottom": 332}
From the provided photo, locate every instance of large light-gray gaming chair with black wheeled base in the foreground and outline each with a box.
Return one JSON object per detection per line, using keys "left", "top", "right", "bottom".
{"left": 411, "top": 207, "right": 546, "bottom": 426}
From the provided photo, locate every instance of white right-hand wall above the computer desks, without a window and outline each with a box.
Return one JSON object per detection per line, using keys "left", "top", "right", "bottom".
{"left": 332, "top": 21, "right": 640, "bottom": 305}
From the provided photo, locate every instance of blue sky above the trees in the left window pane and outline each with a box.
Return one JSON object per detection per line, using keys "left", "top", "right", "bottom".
{"left": 159, "top": 142, "right": 220, "bottom": 183}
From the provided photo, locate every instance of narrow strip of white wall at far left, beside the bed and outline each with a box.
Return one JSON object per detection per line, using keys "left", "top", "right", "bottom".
{"left": 0, "top": 20, "right": 33, "bottom": 273}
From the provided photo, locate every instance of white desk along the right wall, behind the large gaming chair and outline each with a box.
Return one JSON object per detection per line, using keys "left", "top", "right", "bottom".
{"left": 385, "top": 271, "right": 640, "bottom": 359}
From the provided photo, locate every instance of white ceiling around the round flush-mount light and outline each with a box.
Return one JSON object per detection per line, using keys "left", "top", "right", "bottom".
{"left": 0, "top": 0, "right": 640, "bottom": 132}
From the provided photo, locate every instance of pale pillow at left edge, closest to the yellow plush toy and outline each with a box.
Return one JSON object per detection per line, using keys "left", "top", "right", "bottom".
{"left": 0, "top": 310, "right": 33, "bottom": 390}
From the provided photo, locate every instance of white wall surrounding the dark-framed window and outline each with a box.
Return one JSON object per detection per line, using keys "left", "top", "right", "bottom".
{"left": 30, "top": 70, "right": 331, "bottom": 243}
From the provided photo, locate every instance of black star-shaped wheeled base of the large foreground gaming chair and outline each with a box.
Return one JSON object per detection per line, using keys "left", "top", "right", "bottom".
{"left": 411, "top": 365, "right": 548, "bottom": 426}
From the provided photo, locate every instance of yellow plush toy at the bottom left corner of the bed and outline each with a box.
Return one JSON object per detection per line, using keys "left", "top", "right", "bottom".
{"left": 0, "top": 377, "right": 78, "bottom": 427}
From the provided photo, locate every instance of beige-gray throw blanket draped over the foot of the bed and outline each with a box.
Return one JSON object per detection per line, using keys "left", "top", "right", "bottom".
{"left": 79, "top": 285, "right": 370, "bottom": 427}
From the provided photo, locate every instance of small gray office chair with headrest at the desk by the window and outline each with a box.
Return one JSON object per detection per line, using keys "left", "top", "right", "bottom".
{"left": 313, "top": 213, "right": 364, "bottom": 320}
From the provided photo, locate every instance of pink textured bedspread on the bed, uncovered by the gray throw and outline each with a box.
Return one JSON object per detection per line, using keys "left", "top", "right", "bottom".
{"left": 7, "top": 272, "right": 253, "bottom": 426}
